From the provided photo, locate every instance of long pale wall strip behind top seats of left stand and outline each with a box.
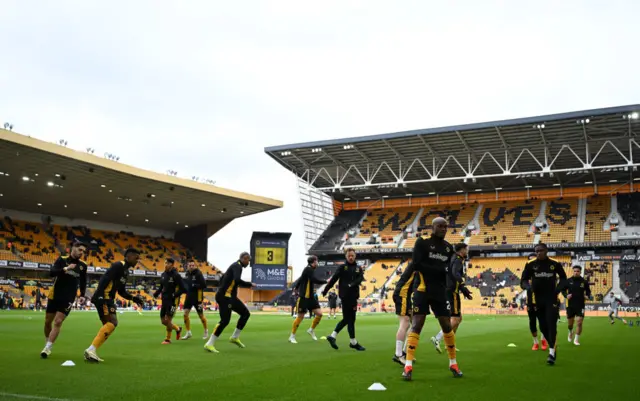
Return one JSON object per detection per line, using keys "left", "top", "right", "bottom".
{"left": 0, "top": 209, "right": 175, "bottom": 238}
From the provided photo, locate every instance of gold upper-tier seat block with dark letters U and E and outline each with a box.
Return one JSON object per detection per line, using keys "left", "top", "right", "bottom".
{"left": 469, "top": 200, "right": 541, "bottom": 245}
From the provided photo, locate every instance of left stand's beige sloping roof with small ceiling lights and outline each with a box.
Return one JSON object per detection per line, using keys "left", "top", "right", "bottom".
{"left": 0, "top": 129, "right": 282, "bottom": 231}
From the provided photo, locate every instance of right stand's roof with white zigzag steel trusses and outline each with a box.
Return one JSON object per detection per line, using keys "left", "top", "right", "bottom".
{"left": 265, "top": 105, "right": 640, "bottom": 199}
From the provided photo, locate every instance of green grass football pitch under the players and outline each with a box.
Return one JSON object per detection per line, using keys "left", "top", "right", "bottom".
{"left": 0, "top": 311, "right": 640, "bottom": 401}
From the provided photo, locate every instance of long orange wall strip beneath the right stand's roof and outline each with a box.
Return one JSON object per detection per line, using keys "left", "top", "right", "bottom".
{"left": 343, "top": 184, "right": 632, "bottom": 210}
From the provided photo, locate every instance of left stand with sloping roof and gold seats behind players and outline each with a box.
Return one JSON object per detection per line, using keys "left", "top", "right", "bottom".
{"left": 0, "top": 129, "right": 282, "bottom": 308}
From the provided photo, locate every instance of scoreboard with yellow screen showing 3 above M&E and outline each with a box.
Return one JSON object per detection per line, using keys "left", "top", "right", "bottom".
{"left": 250, "top": 232, "right": 291, "bottom": 290}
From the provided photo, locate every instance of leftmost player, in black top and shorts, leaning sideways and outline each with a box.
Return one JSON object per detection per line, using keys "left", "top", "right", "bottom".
{"left": 36, "top": 242, "right": 87, "bottom": 358}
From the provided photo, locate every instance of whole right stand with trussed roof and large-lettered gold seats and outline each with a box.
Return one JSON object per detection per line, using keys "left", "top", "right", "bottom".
{"left": 265, "top": 105, "right": 640, "bottom": 316}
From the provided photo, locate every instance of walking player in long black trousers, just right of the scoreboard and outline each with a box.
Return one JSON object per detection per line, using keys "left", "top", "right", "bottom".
{"left": 322, "top": 248, "right": 365, "bottom": 351}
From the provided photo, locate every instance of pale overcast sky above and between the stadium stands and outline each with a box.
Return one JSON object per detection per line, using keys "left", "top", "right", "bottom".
{"left": 0, "top": 0, "right": 640, "bottom": 278}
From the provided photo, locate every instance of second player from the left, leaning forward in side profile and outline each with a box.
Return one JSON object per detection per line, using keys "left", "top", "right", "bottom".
{"left": 84, "top": 248, "right": 143, "bottom": 362}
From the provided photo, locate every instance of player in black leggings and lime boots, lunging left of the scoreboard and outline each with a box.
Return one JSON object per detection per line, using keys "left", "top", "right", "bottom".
{"left": 204, "top": 252, "right": 256, "bottom": 353}
